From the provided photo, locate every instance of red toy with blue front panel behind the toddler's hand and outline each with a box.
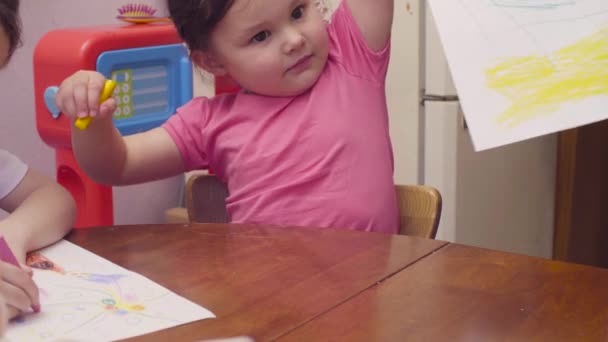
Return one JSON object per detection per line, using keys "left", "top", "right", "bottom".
{"left": 34, "top": 24, "right": 192, "bottom": 228}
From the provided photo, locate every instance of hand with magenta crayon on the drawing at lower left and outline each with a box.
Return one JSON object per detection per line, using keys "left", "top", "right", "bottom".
{"left": 0, "top": 261, "right": 40, "bottom": 320}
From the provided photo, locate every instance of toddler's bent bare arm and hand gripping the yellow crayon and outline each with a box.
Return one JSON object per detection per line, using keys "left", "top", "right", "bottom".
{"left": 57, "top": 71, "right": 184, "bottom": 185}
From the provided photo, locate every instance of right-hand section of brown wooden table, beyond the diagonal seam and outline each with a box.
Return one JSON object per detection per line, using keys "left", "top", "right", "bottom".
{"left": 279, "top": 244, "right": 608, "bottom": 341}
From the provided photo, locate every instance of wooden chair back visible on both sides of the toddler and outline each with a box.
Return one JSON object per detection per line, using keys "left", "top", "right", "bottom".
{"left": 186, "top": 174, "right": 441, "bottom": 239}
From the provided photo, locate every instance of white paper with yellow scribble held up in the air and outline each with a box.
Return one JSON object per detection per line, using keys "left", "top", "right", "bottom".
{"left": 429, "top": 0, "right": 608, "bottom": 150}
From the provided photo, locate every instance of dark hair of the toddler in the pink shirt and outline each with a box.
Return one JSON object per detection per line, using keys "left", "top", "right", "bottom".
{"left": 167, "top": 0, "right": 234, "bottom": 51}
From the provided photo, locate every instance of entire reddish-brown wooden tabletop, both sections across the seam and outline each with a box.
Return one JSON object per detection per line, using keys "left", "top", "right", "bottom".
{"left": 69, "top": 225, "right": 608, "bottom": 341}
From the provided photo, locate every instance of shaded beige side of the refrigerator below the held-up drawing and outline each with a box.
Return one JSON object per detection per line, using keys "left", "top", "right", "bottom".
{"left": 455, "top": 124, "right": 557, "bottom": 258}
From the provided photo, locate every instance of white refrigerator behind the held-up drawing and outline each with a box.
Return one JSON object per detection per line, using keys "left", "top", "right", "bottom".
{"left": 420, "top": 0, "right": 557, "bottom": 257}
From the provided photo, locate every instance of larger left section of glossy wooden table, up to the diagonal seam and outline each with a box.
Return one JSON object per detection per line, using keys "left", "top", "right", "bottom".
{"left": 68, "top": 224, "right": 445, "bottom": 341}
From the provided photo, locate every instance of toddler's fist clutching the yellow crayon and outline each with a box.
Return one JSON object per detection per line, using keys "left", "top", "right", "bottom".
{"left": 55, "top": 70, "right": 116, "bottom": 121}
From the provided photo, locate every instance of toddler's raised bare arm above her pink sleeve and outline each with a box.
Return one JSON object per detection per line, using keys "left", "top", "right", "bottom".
{"left": 343, "top": 0, "right": 394, "bottom": 51}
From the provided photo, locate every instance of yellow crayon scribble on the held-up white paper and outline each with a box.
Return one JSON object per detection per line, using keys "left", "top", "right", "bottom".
{"left": 486, "top": 28, "right": 608, "bottom": 127}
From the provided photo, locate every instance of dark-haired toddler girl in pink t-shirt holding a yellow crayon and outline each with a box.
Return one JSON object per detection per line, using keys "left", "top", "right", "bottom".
{"left": 57, "top": 0, "right": 398, "bottom": 233}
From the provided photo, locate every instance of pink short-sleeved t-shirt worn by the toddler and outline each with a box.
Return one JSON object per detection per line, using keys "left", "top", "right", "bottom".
{"left": 163, "top": 2, "right": 399, "bottom": 233}
